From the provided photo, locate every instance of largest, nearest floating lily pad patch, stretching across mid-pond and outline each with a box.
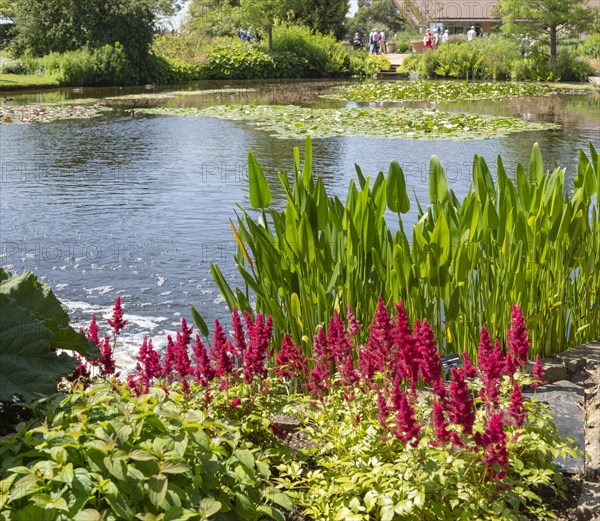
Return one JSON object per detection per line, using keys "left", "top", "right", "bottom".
{"left": 141, "top": 105, "right": 558, "bottom": 139}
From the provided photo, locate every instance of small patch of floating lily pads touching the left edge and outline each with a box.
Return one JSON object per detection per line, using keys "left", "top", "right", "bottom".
{"left": 0, "top": 103, "right": 111, "bottom": 124}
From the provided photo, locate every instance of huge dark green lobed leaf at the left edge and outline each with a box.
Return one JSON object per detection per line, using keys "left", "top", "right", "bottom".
{"left": 0, "top": 268, "right": 99, "bottom": 401}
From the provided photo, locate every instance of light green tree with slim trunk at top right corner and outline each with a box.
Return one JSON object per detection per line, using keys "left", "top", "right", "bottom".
{"left": 498, "top": 0, "right": 597, "bottom": 64}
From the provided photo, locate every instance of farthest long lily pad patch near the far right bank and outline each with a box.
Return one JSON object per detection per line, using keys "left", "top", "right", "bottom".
{"left": 323, "top": 81, "right": 562, "bottom": 102}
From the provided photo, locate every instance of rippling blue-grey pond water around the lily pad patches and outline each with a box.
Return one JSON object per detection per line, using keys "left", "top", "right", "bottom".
{"left": 0, "top": 81, "right": 600, "bottom": 361}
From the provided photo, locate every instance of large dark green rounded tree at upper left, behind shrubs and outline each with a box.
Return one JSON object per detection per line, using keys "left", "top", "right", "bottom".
{"left": 9, "top": 0, "right": 179, "bottom": 66}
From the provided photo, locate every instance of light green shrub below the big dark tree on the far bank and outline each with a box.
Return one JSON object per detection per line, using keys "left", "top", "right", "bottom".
{"left": 41, "top": 42, "right": 136, "bottom": 85}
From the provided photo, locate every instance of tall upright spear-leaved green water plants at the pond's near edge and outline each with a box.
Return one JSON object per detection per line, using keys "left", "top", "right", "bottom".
{"left": 207, "top": 141, "right": 600, "bottom": 362}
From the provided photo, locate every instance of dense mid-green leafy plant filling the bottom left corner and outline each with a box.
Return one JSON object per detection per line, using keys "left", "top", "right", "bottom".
{"left": 0, "top": 382, "right": 291, "bottom": 521}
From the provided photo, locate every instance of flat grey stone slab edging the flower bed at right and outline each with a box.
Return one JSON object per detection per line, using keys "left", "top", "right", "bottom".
{"left": 523, "top": 378, "right": 585, "bottom": 474}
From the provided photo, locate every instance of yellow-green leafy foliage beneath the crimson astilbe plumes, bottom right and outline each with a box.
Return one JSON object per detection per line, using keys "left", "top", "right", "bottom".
{"left": 278, "top": 380, "right": 574, "bottom": 521}
